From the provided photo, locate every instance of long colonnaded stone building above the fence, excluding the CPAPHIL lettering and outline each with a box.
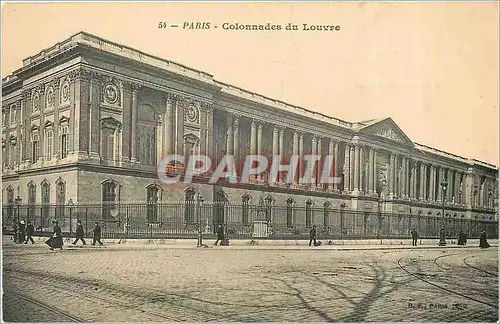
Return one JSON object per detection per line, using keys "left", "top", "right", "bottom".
{"left": 2, "top": 32, "right": 498, "bottom": 227}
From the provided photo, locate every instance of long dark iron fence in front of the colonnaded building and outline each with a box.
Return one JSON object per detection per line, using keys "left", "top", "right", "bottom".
{"left": 2, "top": 202, "right": 498, "bottom": 239}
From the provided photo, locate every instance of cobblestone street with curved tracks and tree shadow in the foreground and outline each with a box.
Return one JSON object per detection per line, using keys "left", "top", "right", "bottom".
{"left": 3, "top": 241, "right": 498, "bottom": 322}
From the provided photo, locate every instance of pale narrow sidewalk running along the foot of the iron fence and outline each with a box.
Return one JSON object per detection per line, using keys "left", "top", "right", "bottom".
{"left": 2, "top": 236, "right": 498, "bottom": 250}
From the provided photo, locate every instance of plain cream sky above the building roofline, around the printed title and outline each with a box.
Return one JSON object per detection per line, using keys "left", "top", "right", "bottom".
{"left": 2, "top": 2, "right": 499, "bottom": 166}
